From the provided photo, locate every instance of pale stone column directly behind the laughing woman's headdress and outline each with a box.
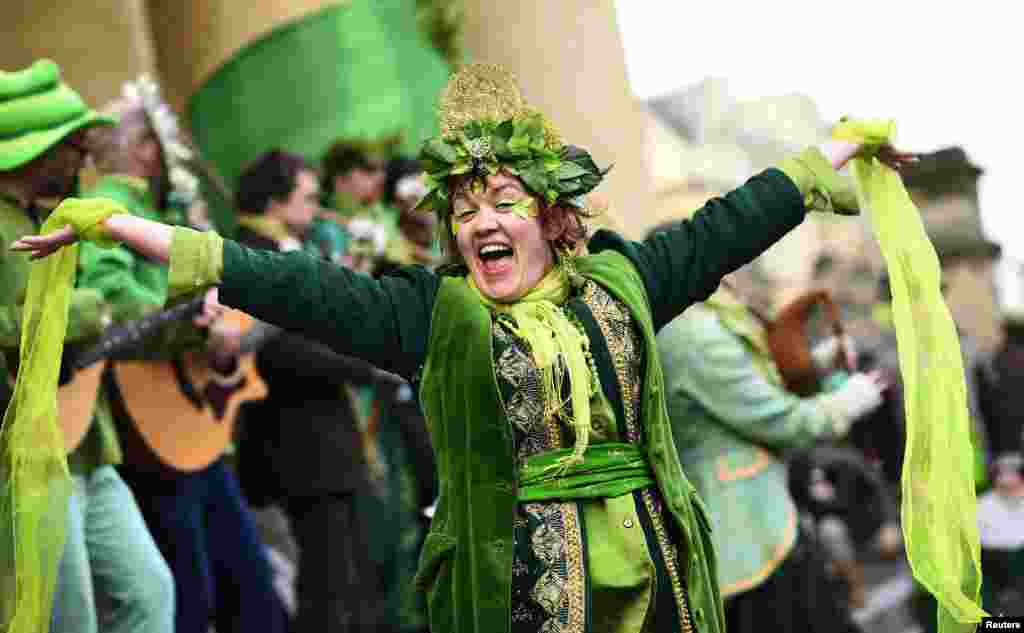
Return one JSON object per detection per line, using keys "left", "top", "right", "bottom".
{"left": 465, "top": 0, "right": 653, "bottom": 238}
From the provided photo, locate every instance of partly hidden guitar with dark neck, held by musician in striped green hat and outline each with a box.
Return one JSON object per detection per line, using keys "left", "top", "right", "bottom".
{"left": 7, "top": 297, "right": 203, "bottom": 455}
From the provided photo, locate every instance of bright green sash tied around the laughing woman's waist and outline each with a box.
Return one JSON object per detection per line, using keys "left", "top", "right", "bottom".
{"left": 518, "top": 441, "right": 655, "bottom": 503}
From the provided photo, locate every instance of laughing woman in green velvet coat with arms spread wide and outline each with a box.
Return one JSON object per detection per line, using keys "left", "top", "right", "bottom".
{"left": 16, "top": 65, "right": 908, "bottom": 633}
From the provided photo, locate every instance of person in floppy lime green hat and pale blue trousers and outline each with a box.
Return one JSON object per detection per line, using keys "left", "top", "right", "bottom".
{"left": 0, "top": 59, "right": 174, "bottom": 633}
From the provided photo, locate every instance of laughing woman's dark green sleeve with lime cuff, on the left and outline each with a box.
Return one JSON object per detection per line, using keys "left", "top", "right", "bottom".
{"left": 170, "top": 228, "right": 440, "bottom": 379}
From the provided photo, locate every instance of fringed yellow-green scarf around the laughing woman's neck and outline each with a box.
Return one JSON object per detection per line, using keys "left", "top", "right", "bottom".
{"left": 466, "top": 265, "right": 594, "bottom": 466}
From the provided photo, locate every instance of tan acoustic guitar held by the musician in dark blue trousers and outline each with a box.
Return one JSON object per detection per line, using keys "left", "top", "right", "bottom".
{"left": 106, "top": 310, "right": 280, "bottom": 477}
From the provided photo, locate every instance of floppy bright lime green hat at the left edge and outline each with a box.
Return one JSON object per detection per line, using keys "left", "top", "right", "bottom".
{"left": 0, "top": 59, "right": 117, "bottom": 171}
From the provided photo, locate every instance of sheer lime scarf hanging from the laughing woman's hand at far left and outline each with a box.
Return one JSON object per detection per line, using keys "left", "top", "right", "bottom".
{"left": 0, "top": 199, "right": 120, "bottom": 633}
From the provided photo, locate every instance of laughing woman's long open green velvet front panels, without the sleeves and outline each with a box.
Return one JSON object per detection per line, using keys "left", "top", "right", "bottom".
{"left": 417, "top": 250, "right": 725, "bottom": 632}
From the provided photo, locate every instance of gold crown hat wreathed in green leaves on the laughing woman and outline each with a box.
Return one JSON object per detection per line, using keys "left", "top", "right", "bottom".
{"left": 417, "top": 64, "right": 608, "bottom": 221}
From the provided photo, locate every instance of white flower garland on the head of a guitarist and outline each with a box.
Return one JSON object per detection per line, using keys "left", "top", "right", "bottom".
{"left": 106, "top": 74, "right": 200, "bottom": 204}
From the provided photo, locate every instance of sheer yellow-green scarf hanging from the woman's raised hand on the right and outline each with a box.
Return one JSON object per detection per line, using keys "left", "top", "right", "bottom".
{"left": 833, "top": 120, "right": 987, "bottom": 633}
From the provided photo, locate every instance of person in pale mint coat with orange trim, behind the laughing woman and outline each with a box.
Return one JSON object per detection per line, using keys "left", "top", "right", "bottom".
{"left": 657, "top": 276, "right": 885, "bottom": 633}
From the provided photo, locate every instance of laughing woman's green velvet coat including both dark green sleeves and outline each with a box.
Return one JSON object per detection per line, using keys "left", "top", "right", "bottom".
{"left": 184, "top": 165, "right": 814, "bottom": 633}
